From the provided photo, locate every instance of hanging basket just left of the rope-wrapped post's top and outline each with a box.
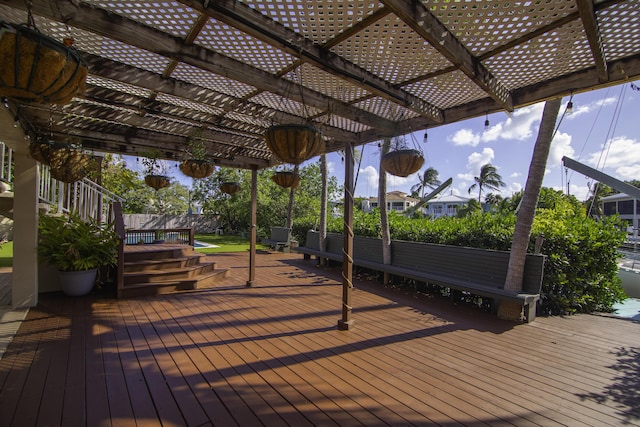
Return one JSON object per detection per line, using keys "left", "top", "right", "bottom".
{"left": 264, "top": 124, "right": 325, "bottom": 165}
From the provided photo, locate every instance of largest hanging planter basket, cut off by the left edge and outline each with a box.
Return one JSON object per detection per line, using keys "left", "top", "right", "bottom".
{"left": 0, "top": 21, "right": 87, "bottom": 104}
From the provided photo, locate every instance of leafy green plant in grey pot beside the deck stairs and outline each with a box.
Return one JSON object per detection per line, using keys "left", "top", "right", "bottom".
{"left": 38, "top": 213, "right": 119, "bottom": 296}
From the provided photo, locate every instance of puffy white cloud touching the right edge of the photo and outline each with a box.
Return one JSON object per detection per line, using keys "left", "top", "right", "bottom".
{"left": 587, "top": 136, "right": 640, "bottom": 180}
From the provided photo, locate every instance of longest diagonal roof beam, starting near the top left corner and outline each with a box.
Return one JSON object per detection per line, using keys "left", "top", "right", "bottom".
{"left": 10, "top": 0, "right": 398, "bottom": 132}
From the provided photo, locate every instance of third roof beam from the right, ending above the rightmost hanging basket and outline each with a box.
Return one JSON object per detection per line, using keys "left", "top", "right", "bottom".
{"left": 180, "top": 0, "right": 442, "bottom": 122}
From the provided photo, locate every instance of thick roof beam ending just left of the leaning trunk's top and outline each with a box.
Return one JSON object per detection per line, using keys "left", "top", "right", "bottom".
{"left": 381, "top": 0, "right": 513, "bottom": 111}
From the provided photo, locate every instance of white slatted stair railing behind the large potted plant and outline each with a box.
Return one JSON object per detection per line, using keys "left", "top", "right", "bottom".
{"left": 38, "top": 164, "right": 124, "bottom": 222}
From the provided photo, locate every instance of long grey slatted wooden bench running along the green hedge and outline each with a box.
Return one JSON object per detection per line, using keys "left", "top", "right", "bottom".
{"left": 296, "top": 231, "right": 545, "bottom": 322}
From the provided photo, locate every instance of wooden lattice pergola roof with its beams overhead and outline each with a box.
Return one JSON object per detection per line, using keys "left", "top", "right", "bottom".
{"left": 0, "top": 0, "right": 640, "bottom": 168}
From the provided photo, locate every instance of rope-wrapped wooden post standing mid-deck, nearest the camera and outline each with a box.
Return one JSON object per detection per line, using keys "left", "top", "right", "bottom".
{"left": 338, "top": 143, "right": 354, "bottom": 331}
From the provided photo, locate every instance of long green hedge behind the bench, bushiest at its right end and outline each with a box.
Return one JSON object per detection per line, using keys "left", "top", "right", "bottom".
{"left": 332, "top": 199, "right": 625, "bottom": 315}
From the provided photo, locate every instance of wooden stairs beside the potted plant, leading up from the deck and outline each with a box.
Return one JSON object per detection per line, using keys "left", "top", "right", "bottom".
{"left": 122, "top": 245, "right": 229, "bottom": 298}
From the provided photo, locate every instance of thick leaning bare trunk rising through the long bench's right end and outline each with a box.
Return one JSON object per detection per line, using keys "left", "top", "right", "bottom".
{"left": 498, "top": 98, "right": 561, "bottom": 320}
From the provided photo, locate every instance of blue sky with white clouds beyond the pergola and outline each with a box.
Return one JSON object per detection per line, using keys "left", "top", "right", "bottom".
{"left": 145, "top": 82, "right": 640, "bottom": 200}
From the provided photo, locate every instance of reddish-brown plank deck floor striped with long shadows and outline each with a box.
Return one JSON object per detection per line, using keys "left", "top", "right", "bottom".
{"left": 0, "top": 253, "right": 640, "bottom": 426}
